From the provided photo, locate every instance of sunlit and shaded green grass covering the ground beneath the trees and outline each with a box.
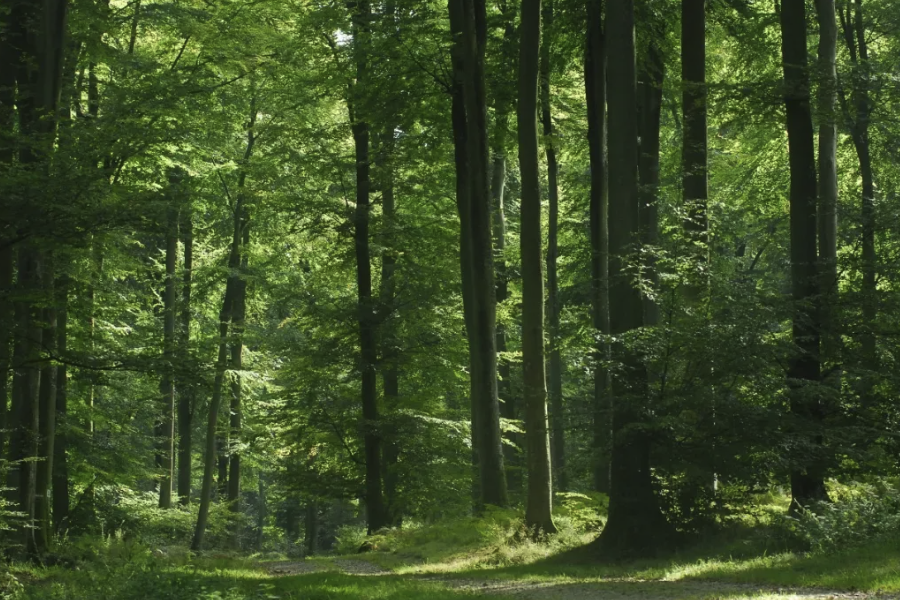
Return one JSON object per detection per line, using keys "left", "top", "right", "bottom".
{"left": 10, "top": 495, "right": 900, "bottom": 600}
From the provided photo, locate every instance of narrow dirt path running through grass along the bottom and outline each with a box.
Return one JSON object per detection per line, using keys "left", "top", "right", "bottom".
{"left": 266, "top": 558, "right": 884, "bottom": 600}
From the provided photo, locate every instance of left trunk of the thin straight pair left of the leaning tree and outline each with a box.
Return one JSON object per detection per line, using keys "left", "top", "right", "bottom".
{"left": 157, "top": 199, "right": 178, "bottom": 508}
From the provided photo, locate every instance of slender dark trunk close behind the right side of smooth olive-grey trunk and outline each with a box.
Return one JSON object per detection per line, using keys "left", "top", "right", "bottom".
{"left": 540, "top": 0, "right": 569, "bottom": 491}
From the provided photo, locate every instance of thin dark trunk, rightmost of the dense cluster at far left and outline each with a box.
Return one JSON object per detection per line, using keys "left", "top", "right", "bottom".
{"left": 52, "top": 273, "right": 70, "bottom": 534}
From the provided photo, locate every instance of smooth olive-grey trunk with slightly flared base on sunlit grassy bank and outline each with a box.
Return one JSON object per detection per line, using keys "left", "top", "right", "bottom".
{"left": 517, "top": 0, "right": 556, "bottom": 534}
